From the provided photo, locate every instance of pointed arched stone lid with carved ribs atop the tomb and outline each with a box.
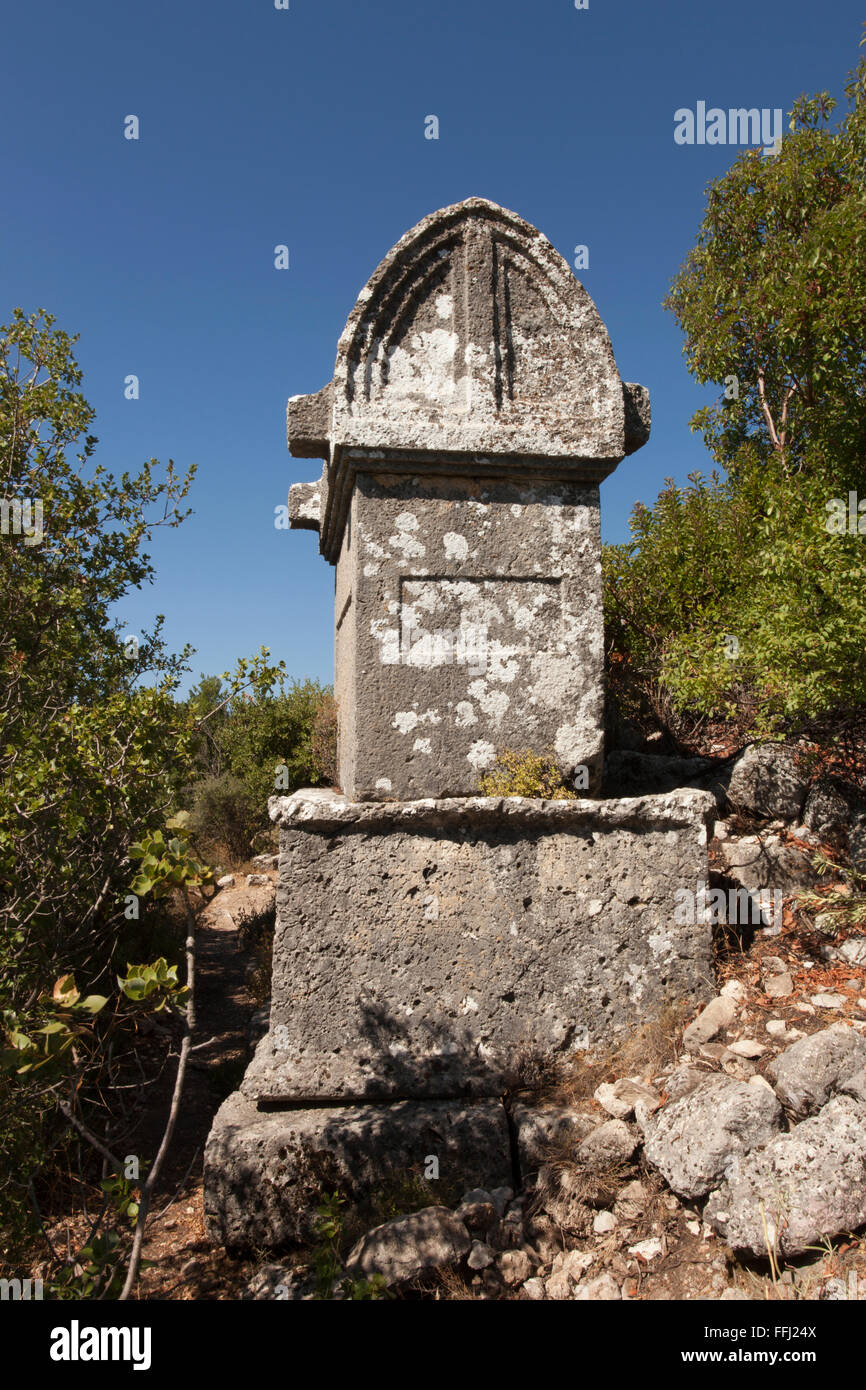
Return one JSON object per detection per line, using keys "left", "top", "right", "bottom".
{"left": 288, "top": 197, "right": 644, "bottom": 464}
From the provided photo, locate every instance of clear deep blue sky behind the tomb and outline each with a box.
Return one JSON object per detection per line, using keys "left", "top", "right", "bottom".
{"left": 0, "top": 0, "right": 863, "bottom": 695}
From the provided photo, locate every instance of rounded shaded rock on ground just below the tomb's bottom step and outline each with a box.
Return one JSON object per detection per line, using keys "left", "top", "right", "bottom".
{"left": 346, "top": 1207, "right": 471, "bottom": 1284}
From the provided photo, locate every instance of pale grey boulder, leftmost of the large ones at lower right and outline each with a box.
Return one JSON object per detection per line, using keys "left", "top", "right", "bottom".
{"left": 644, "top": 1074, "right": 783, "bottom": 1198}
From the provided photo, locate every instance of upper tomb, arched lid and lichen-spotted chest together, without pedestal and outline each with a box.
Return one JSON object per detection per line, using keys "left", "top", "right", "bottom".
{"left": 288, "top": 197, "right": 651, "bottom": 799}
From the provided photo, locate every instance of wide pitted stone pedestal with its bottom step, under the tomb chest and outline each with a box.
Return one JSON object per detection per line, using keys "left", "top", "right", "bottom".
{"left": 204, "top": 791, "right": 714, "bottom": 1245}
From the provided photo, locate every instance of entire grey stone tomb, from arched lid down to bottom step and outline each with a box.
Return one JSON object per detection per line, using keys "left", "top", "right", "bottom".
{"left": 206, "top": 199, "right": 714, "bottom": 1245}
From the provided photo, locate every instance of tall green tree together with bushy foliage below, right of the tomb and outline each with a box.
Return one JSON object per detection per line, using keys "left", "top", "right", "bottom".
{"left": 603, "top": 46, "right": 866, "bottom": 735}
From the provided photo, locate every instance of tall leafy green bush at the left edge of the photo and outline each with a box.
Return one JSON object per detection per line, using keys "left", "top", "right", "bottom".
{"left": 0, "top": 310, "right": 193, "bottom": 1251}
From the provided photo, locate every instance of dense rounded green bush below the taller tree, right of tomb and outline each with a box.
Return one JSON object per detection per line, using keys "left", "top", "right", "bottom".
{"left": 603, "top": 459, "right": 866, "bottom": 734}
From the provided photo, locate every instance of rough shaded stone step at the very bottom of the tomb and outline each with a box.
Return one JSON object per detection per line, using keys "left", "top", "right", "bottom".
{"left": 204, "top": 1091, "right": 512, "bottom": 1250}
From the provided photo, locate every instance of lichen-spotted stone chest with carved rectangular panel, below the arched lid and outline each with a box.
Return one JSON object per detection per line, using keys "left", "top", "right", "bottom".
{"left": 335, "top": 473, "right": 605, "bottom": 801}
